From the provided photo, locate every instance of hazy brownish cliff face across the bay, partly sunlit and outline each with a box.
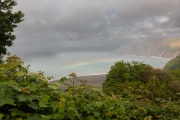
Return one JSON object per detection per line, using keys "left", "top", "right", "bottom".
{"left": 114, "top": 38, "right": 180, "bottom": 58}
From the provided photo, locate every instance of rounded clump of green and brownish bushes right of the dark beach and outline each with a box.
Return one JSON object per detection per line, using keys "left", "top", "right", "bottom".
{"left": 103, "top": 61, "right": 179, "bottom": 100}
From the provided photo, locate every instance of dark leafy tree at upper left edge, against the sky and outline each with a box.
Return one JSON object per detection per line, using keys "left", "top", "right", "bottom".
{"left": 0, "top": 0, "right": 24, "bottom": 57}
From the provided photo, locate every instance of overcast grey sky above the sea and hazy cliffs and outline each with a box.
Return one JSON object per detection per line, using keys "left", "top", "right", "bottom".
{"left": 9, "top": 0, "right": 180, "bottom": 59}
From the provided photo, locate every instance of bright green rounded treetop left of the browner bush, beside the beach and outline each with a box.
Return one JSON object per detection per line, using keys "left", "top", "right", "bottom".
{"left": 103, "top": 61, "right": 146, "bottom": 92}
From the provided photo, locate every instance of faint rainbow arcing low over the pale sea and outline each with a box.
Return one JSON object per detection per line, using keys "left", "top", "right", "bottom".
{"left": 58, "top": 58, "right": 122, "bottom": 71}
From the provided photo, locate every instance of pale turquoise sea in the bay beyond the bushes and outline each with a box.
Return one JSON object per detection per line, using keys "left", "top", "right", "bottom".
{"left": 24, "top": 52, "right": 170, "bottom": 80}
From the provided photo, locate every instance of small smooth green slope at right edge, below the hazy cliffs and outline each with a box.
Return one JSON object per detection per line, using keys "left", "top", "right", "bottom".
{"left": 163, "top": 55, "right": 180, "bottom": 70}
